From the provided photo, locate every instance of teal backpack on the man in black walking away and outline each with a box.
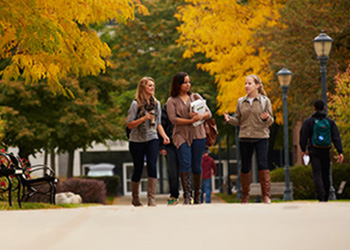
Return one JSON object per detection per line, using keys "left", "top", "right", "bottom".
{"left": 311, "top": 119, "right": 332, "bottom": 148}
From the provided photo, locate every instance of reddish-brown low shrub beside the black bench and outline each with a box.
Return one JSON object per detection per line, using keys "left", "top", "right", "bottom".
{"left": 57, "top": 178, "right": 106, "bottom": 203}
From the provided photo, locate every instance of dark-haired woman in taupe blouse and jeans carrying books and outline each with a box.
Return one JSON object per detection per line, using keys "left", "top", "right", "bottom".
{"left": 167, "top": 72, "right": 211, "bottom": 204}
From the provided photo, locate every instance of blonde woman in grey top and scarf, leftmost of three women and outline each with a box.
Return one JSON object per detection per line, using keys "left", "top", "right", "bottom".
{"left": 126, "top": 77, "right": 170, "bottom": 206}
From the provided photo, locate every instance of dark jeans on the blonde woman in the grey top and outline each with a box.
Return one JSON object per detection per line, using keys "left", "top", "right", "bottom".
{"left": 129, "top": 139, "right": 159, "bottom": 182}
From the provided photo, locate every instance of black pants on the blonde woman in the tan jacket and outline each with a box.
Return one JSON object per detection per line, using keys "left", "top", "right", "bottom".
{"left": 239, "top": 139, "right": 269, "bottom": 174}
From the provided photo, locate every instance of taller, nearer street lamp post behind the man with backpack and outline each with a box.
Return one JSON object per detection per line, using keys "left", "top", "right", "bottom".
{"left": 313, "top": 30, "right": 336, "bottom": 200}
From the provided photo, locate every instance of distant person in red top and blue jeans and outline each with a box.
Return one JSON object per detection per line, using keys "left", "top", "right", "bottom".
{"left": 201, "top": 147, "right": 216, "bottom": 203}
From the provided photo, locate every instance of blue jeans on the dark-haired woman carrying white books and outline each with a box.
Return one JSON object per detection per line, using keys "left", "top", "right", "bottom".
{"left": 178, "top": 138, "right": 207, "bottom": 174}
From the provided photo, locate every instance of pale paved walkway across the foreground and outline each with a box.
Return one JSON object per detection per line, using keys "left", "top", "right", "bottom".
{"left": 0, "top": 202, "right": 350, "bottom": 250}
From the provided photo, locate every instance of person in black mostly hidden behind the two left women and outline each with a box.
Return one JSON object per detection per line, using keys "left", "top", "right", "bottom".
{"left": 159, "top": 104, "right": 180, "bottom": 205}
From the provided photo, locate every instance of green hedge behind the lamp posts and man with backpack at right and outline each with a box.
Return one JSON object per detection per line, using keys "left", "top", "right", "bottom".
{"left": 271, "top": 164, "right": 350, "bottom": 200}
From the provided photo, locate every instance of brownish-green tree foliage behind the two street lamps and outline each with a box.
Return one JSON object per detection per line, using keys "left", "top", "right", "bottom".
{"left": 255, "top": 0, "right": 350, "bottom": 124}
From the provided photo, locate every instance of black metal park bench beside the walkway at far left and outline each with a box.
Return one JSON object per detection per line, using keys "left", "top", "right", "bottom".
{"left": 0, "top": 153, "right": 58, "bottom": 207}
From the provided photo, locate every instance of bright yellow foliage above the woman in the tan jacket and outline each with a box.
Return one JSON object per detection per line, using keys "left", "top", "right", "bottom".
{"left": 176, "top": 0, "right": 283, "bottom": 123}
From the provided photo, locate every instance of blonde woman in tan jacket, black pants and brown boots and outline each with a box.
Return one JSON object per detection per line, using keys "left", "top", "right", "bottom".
{"left": 224, "top": 75, "right": 274, "bottom": 203}
